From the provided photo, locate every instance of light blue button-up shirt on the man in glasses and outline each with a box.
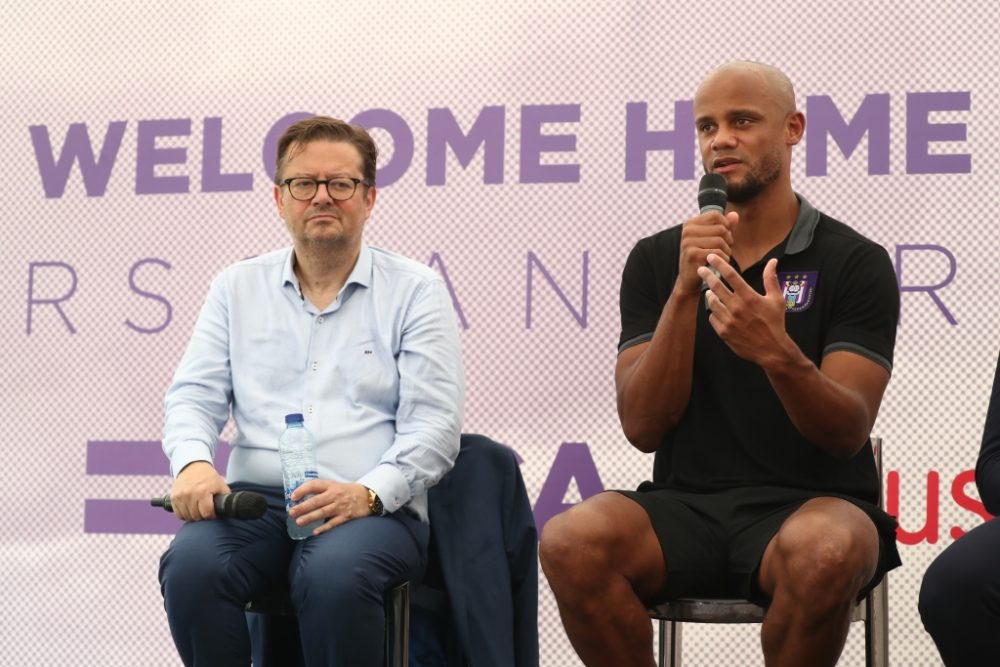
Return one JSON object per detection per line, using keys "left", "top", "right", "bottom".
{"left": 163, "top": 244, "right": 465, "bottom": 521}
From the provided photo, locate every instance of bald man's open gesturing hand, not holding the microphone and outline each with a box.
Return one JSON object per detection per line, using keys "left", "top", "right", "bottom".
{"left": 698, "top": 253, "right": 788, "bottom": 370}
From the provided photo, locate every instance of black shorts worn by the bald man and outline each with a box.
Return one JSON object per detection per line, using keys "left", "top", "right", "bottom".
{"left": 618, "top": 482, "right": 901, "bottom": 606}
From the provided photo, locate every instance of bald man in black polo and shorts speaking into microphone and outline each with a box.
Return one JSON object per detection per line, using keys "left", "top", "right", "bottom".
{"left": 540, "top": 62, "right": 899, "bottom": 667}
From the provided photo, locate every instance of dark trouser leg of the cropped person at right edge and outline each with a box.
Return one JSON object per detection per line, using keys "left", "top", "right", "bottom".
{"left": 919, "top": 518, "right": 1000, "bottom": 667}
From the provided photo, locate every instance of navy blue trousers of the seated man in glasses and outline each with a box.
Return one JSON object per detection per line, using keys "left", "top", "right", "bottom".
{"left": 160, "top": 484, "right": 430, "bottom": 667}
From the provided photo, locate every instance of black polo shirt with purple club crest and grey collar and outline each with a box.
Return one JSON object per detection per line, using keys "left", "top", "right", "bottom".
{"left": 618, "top": 195, "right": 899, "bottom": 503}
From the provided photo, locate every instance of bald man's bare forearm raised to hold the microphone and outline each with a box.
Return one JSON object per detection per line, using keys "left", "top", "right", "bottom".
{"left": 615, "top": 287, "right": 701, "bottom": 452}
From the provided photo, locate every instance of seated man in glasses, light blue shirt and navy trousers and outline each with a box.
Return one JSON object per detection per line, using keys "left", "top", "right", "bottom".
{"left": 160, "top": 117, "right": 464, "bottom": 666}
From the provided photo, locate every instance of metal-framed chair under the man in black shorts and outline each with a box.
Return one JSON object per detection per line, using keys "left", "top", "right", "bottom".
{"left": 649, "top": 437, "right": 889, "bottom": 667}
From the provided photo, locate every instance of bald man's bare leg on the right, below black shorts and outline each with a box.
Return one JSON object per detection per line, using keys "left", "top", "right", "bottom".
{"left": 760, "top": 498, "right": 878, "bottom": 667}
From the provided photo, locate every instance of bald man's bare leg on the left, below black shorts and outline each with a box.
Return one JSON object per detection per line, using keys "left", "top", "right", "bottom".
{"left": 539, "top": 492, "right": 666, "bottom": 667}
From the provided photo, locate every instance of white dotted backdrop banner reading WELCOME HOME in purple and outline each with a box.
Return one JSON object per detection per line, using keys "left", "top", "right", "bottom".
{"left": 0, "top": 0, "right": 1000, "bottom": 667}
